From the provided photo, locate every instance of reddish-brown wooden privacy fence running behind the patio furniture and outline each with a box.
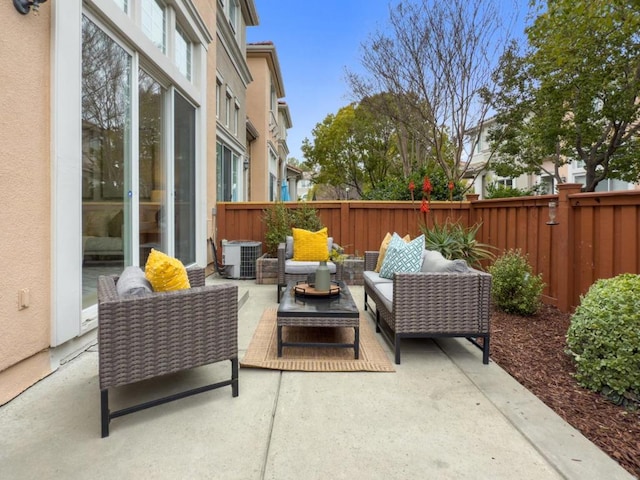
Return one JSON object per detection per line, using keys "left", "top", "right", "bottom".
{"left": 215, "top": 184, "right": 640, "bottom": 312}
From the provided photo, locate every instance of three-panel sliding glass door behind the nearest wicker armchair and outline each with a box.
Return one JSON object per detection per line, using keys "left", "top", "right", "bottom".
{"left": 82, "top": 14, "right": 196, "bottom": 307}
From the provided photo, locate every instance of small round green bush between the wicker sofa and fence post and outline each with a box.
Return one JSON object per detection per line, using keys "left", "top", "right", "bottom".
{"left": 488, "top": 250, "right": 544, "bottom": 316}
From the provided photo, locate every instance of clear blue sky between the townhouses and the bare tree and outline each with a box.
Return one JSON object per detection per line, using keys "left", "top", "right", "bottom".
{"left": 247, "top": 0, "right": 528, "bottom": 161}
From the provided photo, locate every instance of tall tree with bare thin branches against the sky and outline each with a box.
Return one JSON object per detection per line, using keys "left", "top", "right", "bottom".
{"left": 348, "top": 0, "right": 509, "bottom": 188}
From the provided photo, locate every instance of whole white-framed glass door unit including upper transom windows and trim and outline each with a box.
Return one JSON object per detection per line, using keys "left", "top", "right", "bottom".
{"left": 50, "top": 0, "right": 212, "bottom": 348}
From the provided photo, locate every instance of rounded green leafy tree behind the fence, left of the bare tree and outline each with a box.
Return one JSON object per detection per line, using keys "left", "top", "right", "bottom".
{"left": 302, "top": 100, "right": 397, "bottom": 196}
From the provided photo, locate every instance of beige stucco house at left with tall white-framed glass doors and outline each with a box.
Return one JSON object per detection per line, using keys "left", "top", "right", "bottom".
{"left": 0, "top": 0, "right": 268, "bottom": 405}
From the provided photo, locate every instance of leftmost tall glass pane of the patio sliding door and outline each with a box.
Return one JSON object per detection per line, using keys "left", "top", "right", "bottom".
{"left": 82, "top": 17, "right": 131, "bottom": 307}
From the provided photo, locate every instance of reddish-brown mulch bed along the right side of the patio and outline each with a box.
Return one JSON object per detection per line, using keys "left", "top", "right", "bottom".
{"left": 491, "top": 305, "right": 640, "bottom": 478}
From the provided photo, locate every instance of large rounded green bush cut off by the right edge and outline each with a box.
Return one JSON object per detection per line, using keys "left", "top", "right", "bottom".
{"left": 567, "top": 273, "right": 640, "bottom": 407}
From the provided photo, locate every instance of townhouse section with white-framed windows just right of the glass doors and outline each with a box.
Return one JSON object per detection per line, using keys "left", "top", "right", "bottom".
{"left": 215, "top": 0, "right": 258, "bottom": 202}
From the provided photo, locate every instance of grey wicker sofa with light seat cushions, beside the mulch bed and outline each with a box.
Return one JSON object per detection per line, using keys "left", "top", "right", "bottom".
{"left": 364, "top": 251, "right": 491, "bottom": 364}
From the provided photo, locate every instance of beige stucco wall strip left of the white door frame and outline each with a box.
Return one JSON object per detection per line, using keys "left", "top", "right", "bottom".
{"left": 0, "top": 1, "right": 51, "bottom": 405}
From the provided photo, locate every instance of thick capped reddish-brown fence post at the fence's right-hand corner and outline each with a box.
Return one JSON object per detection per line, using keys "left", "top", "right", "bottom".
{"left": 551, "top": 183, "right": 582, "bottom": 313}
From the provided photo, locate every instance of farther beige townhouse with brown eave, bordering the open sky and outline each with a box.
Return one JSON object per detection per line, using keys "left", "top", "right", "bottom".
{"left": 247, "top": 42, "right": 291, "bottom": 202}
